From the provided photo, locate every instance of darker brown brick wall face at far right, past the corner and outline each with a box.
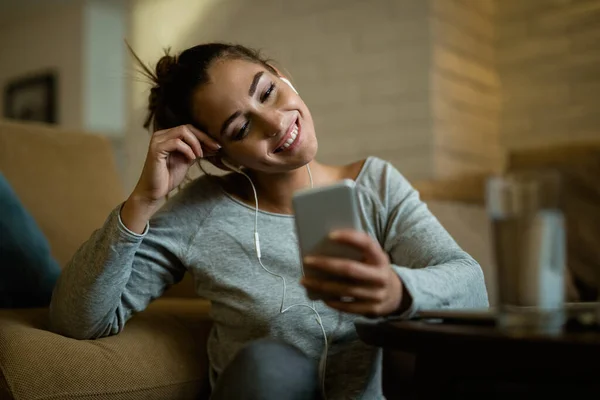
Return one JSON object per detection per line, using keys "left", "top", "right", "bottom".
{"left": 497, "top": 0, "right": 600, "bottom": 149}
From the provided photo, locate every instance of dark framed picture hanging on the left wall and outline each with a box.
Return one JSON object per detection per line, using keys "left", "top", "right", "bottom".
{"left": 4, "top": 72, "right": 58, "bottom": 124}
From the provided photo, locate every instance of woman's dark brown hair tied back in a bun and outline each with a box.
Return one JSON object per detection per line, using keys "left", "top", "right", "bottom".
{"left": 128, "top": 43, "right": 277, "bottom": 131}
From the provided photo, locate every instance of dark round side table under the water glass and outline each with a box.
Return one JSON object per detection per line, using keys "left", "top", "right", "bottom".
{"left": 356, "top": 321, "right": 600, "bottom": 400}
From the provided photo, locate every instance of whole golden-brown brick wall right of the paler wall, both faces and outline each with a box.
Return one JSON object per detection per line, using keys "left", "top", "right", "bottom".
{"left": 431, "top": 0, "right": 600, "bottom": 176}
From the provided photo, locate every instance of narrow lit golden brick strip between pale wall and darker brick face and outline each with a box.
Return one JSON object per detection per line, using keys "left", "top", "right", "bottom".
{"left": 431, "top": 0, "right": 502, "bottom": 177}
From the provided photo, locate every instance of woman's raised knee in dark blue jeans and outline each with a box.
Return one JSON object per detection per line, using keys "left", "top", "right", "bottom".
{"left": 211, "top": 339, "right": 319, "bottom": 400}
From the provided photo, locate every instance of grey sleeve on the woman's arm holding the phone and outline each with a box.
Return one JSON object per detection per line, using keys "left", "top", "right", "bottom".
{"left": 382, "top": 164, "right": 488, "bottom": 317}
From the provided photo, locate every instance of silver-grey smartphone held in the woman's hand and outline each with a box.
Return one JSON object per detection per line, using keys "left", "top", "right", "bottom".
{"left": 292, "top": 179, "right": 363, "bottom": 300}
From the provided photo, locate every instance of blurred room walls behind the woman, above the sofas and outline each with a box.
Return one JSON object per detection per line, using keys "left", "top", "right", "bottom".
{"left": 0, "top": 0, "right": 600, "bottom": 191}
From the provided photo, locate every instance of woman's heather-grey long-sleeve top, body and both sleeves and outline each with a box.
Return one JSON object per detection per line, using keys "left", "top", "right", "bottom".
{"left": 50, "top": 157, "right": 488, "bottom": 400}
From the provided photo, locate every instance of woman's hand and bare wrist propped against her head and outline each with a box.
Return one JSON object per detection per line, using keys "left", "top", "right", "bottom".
{"left": 121, "top": 125, "right": 220, "bottom": 233}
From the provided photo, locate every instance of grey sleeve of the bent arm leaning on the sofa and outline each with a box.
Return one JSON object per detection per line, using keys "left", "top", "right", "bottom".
{"left": 50, "top": 205, "right": 192, "bottom": 339}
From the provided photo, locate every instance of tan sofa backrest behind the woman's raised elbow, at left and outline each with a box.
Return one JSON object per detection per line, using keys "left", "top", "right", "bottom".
{"left": 0, "top": 122, "right": 125, "bottom": 266}
